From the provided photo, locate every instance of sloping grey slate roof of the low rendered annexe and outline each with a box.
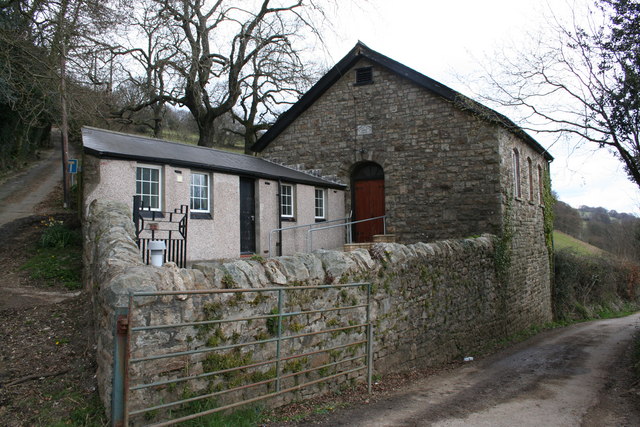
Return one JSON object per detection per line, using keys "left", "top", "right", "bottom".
{"left": 82, "top": 127, "right": 345, "bottom": 189}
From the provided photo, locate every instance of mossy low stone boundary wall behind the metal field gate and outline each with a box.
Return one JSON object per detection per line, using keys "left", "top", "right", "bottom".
{"left": 84, "top": 202, "right": 551, "bottom": 422}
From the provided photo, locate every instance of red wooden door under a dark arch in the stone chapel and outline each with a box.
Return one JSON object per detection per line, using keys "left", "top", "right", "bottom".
{"left": 351, "top": 162, "right": 385, "bottom": 243}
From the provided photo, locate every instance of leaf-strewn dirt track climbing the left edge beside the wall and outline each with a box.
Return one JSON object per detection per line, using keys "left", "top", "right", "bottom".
{"left": 0, "top": 160, "right": 100, "bottom": 427}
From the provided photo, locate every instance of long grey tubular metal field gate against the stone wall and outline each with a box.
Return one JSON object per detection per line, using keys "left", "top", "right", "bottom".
{"left": 112, "top": 283, "right": 373, "bottom": 426}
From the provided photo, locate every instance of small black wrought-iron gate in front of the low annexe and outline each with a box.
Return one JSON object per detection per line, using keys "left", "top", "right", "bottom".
{"left": 133, "top": 196, "right": 189, "bottom": 268}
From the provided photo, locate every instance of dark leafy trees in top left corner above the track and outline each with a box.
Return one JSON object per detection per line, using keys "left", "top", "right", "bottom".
{"left": 0, "top": 0, "right": 119, "bottom": 170}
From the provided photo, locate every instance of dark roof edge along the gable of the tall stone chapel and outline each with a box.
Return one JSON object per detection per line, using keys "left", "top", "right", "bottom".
{"left": 251, "top": 42, "right": 553, "bottom": 161}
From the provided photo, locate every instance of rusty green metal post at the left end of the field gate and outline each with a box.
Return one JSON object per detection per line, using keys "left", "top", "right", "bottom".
{"left": 111, "top": 307, "right": 129, "bottom": 427}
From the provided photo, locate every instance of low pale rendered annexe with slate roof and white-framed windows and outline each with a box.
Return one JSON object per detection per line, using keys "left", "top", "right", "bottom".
{"left": 82, "top": 127, "right": 346, "bottom": 263}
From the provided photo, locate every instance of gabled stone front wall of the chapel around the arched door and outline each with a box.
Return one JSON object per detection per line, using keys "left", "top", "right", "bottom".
{"left": 261, "top": 59, "right": 500, "bottom": 243}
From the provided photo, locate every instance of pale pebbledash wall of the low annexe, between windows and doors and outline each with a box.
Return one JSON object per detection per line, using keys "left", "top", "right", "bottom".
{"left": 84, "top": 156, "right": 345, "bottom": 262}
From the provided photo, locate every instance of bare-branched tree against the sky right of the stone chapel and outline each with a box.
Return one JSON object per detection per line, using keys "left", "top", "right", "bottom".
{"left": 472, "top": 0, "right": 640, "bottom": 186}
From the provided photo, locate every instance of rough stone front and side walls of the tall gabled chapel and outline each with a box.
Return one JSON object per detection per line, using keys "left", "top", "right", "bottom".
{"left": 261, "top": 60, "right": 551, "bottom": 338}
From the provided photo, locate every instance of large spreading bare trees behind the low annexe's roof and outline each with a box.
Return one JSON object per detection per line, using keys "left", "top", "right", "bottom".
{"left": 0, "top": 0, "right": 336, "bottom": 155}
